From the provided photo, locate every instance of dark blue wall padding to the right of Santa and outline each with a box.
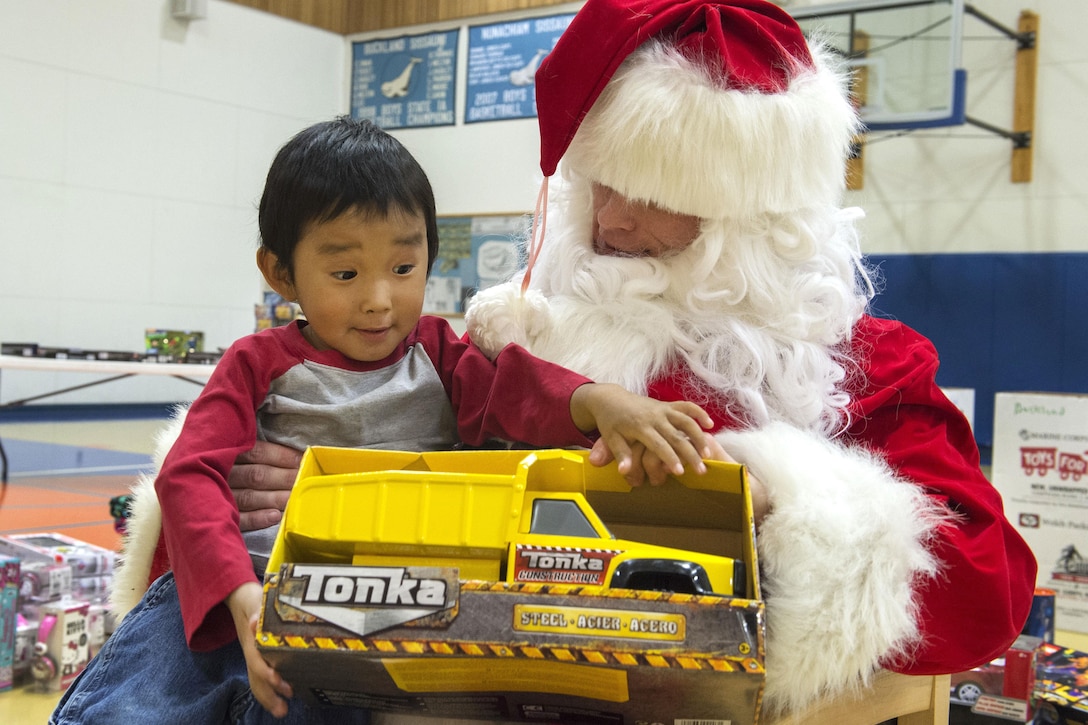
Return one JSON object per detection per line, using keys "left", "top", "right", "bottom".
{"left": 869, "top": 253, "right": 1088, "bottom": 447}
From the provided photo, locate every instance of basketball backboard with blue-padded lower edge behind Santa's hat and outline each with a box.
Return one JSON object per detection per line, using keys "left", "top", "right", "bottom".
{"left": 789, "top": 0, "right": 966, "bottom": 131}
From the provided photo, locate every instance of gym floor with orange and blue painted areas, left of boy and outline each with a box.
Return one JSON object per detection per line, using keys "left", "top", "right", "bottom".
{"left": 0, "top": 411, "right": 164, "bottom": 725}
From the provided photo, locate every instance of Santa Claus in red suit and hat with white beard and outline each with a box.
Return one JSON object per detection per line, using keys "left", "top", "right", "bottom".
{"left": 466, "top": 0, "right": 1036, "bottom": 712}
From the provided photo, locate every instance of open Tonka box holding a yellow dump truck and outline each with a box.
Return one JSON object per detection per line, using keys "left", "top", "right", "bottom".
{"left": 257, "top": 447, "right": 765, "bottom": 725}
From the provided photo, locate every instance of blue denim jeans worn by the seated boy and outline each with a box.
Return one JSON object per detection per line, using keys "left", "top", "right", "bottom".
{"left": 49, "top": 574, "right": 368, "bottom": 725}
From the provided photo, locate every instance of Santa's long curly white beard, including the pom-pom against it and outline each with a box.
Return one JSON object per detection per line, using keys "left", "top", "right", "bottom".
{"left": 466, "top": 171, "right": 870, "bottom": 432}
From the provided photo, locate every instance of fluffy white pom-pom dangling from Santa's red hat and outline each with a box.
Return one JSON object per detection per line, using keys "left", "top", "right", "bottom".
{"left": 465, "top": 282, "right": 552, "bottom": 359}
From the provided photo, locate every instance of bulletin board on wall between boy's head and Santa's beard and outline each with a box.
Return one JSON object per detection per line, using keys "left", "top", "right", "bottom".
{"left": 423, "top": 214, "right": 529, "bottom": 316}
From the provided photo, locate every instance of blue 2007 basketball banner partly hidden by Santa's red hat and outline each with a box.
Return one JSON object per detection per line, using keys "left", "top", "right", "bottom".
{"left": 465, "top": 13, "right": 574, "bottom": 123}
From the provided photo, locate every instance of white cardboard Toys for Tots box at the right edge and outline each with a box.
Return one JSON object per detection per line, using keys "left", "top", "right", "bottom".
{"left": 993, "top": 393, "right": 1088, "bottom": 632}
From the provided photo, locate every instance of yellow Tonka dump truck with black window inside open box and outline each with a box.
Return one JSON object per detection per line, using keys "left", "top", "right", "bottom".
{"left": 269, "top": 448, "right": 746, "bottom": 597}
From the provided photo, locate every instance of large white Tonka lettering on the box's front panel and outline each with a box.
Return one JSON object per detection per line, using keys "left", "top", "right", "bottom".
{"left": 294, "top": 564, "right": 446, "bottom": 607}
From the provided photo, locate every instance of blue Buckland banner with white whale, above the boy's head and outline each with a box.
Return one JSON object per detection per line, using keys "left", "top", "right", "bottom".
{"left": 351, "top": 29, "right": 460, "bottom": 130}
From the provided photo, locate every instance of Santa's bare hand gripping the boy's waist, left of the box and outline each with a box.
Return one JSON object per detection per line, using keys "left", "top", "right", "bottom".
{"left": 227, "top": 441, "right": 302, "bottom": 531}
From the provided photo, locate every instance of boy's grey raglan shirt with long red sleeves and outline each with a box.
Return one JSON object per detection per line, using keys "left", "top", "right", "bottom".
{"left": 151, "top": 317, "right": 592, "bottom": 651}
